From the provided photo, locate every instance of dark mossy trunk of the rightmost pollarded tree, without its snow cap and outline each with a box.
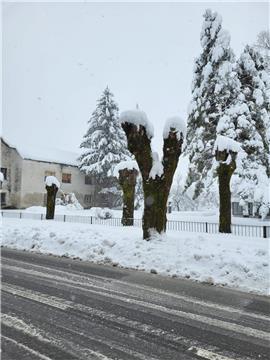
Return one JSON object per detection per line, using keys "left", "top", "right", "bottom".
{"left": 216, "top": 150, "right": 236, "bottom": 233}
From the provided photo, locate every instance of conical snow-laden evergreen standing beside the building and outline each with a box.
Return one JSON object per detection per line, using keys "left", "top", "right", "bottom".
{"left": 79, "top": 87, "right": 130, "bottom": 181}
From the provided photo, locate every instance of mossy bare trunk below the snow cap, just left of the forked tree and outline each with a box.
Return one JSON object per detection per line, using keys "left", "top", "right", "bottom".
{"left": 119, "top": 169, "right": 138, "bottom": 226}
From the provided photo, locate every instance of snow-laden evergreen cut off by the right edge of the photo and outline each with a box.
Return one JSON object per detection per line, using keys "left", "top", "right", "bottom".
{"left": 231, "top": 46, "right": 270, "bottom": 214}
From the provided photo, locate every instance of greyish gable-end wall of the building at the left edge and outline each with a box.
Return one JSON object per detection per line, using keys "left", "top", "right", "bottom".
{"left": 0, "top": 140, "right": 23, "bottom": 207}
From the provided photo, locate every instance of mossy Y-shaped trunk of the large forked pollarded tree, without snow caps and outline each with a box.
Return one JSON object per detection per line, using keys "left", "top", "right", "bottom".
{"left": 122, "top": 122, "right": 183, "bottom": 240}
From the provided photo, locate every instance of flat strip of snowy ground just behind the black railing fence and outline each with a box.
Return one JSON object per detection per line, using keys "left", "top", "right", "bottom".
{"left": 5, "top": 205, "right": 270, "bottom": 226}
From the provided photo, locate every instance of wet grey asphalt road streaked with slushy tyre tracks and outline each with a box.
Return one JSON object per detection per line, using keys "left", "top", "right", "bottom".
{"left": 2, "top": 248, "right": 270, "bottom": 360}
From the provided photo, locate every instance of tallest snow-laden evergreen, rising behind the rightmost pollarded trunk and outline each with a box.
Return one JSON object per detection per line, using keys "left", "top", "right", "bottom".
{"left": 185, "top": 9, "right": 238, "bottom": 199}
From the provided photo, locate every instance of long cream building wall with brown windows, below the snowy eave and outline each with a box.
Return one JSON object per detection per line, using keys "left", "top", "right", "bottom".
{"left": 20, "top": 159, "right": 96, "bottom": 208}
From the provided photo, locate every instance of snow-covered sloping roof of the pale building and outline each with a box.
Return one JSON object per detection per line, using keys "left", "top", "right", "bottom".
{"left": 2, "top": 138, "right": 79, "bottom": 166}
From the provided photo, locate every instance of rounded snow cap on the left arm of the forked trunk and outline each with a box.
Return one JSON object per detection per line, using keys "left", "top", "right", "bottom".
{"left": 119, "top": 109, "right": 154, "bottom": 139}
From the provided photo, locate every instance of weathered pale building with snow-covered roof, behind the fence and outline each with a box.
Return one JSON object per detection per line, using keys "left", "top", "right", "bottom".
{"left": 0, "top": 138, "right": 102, "bottom": 208}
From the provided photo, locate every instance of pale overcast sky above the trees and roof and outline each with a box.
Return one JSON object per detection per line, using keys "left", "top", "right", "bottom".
{"left": 2, "top": 2, "right": 269, "bottom": 156}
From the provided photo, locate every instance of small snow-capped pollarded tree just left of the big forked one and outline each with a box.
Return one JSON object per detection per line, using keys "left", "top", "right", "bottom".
{"left": 115, "top": 161, "right": 139, "bottom": 226}
